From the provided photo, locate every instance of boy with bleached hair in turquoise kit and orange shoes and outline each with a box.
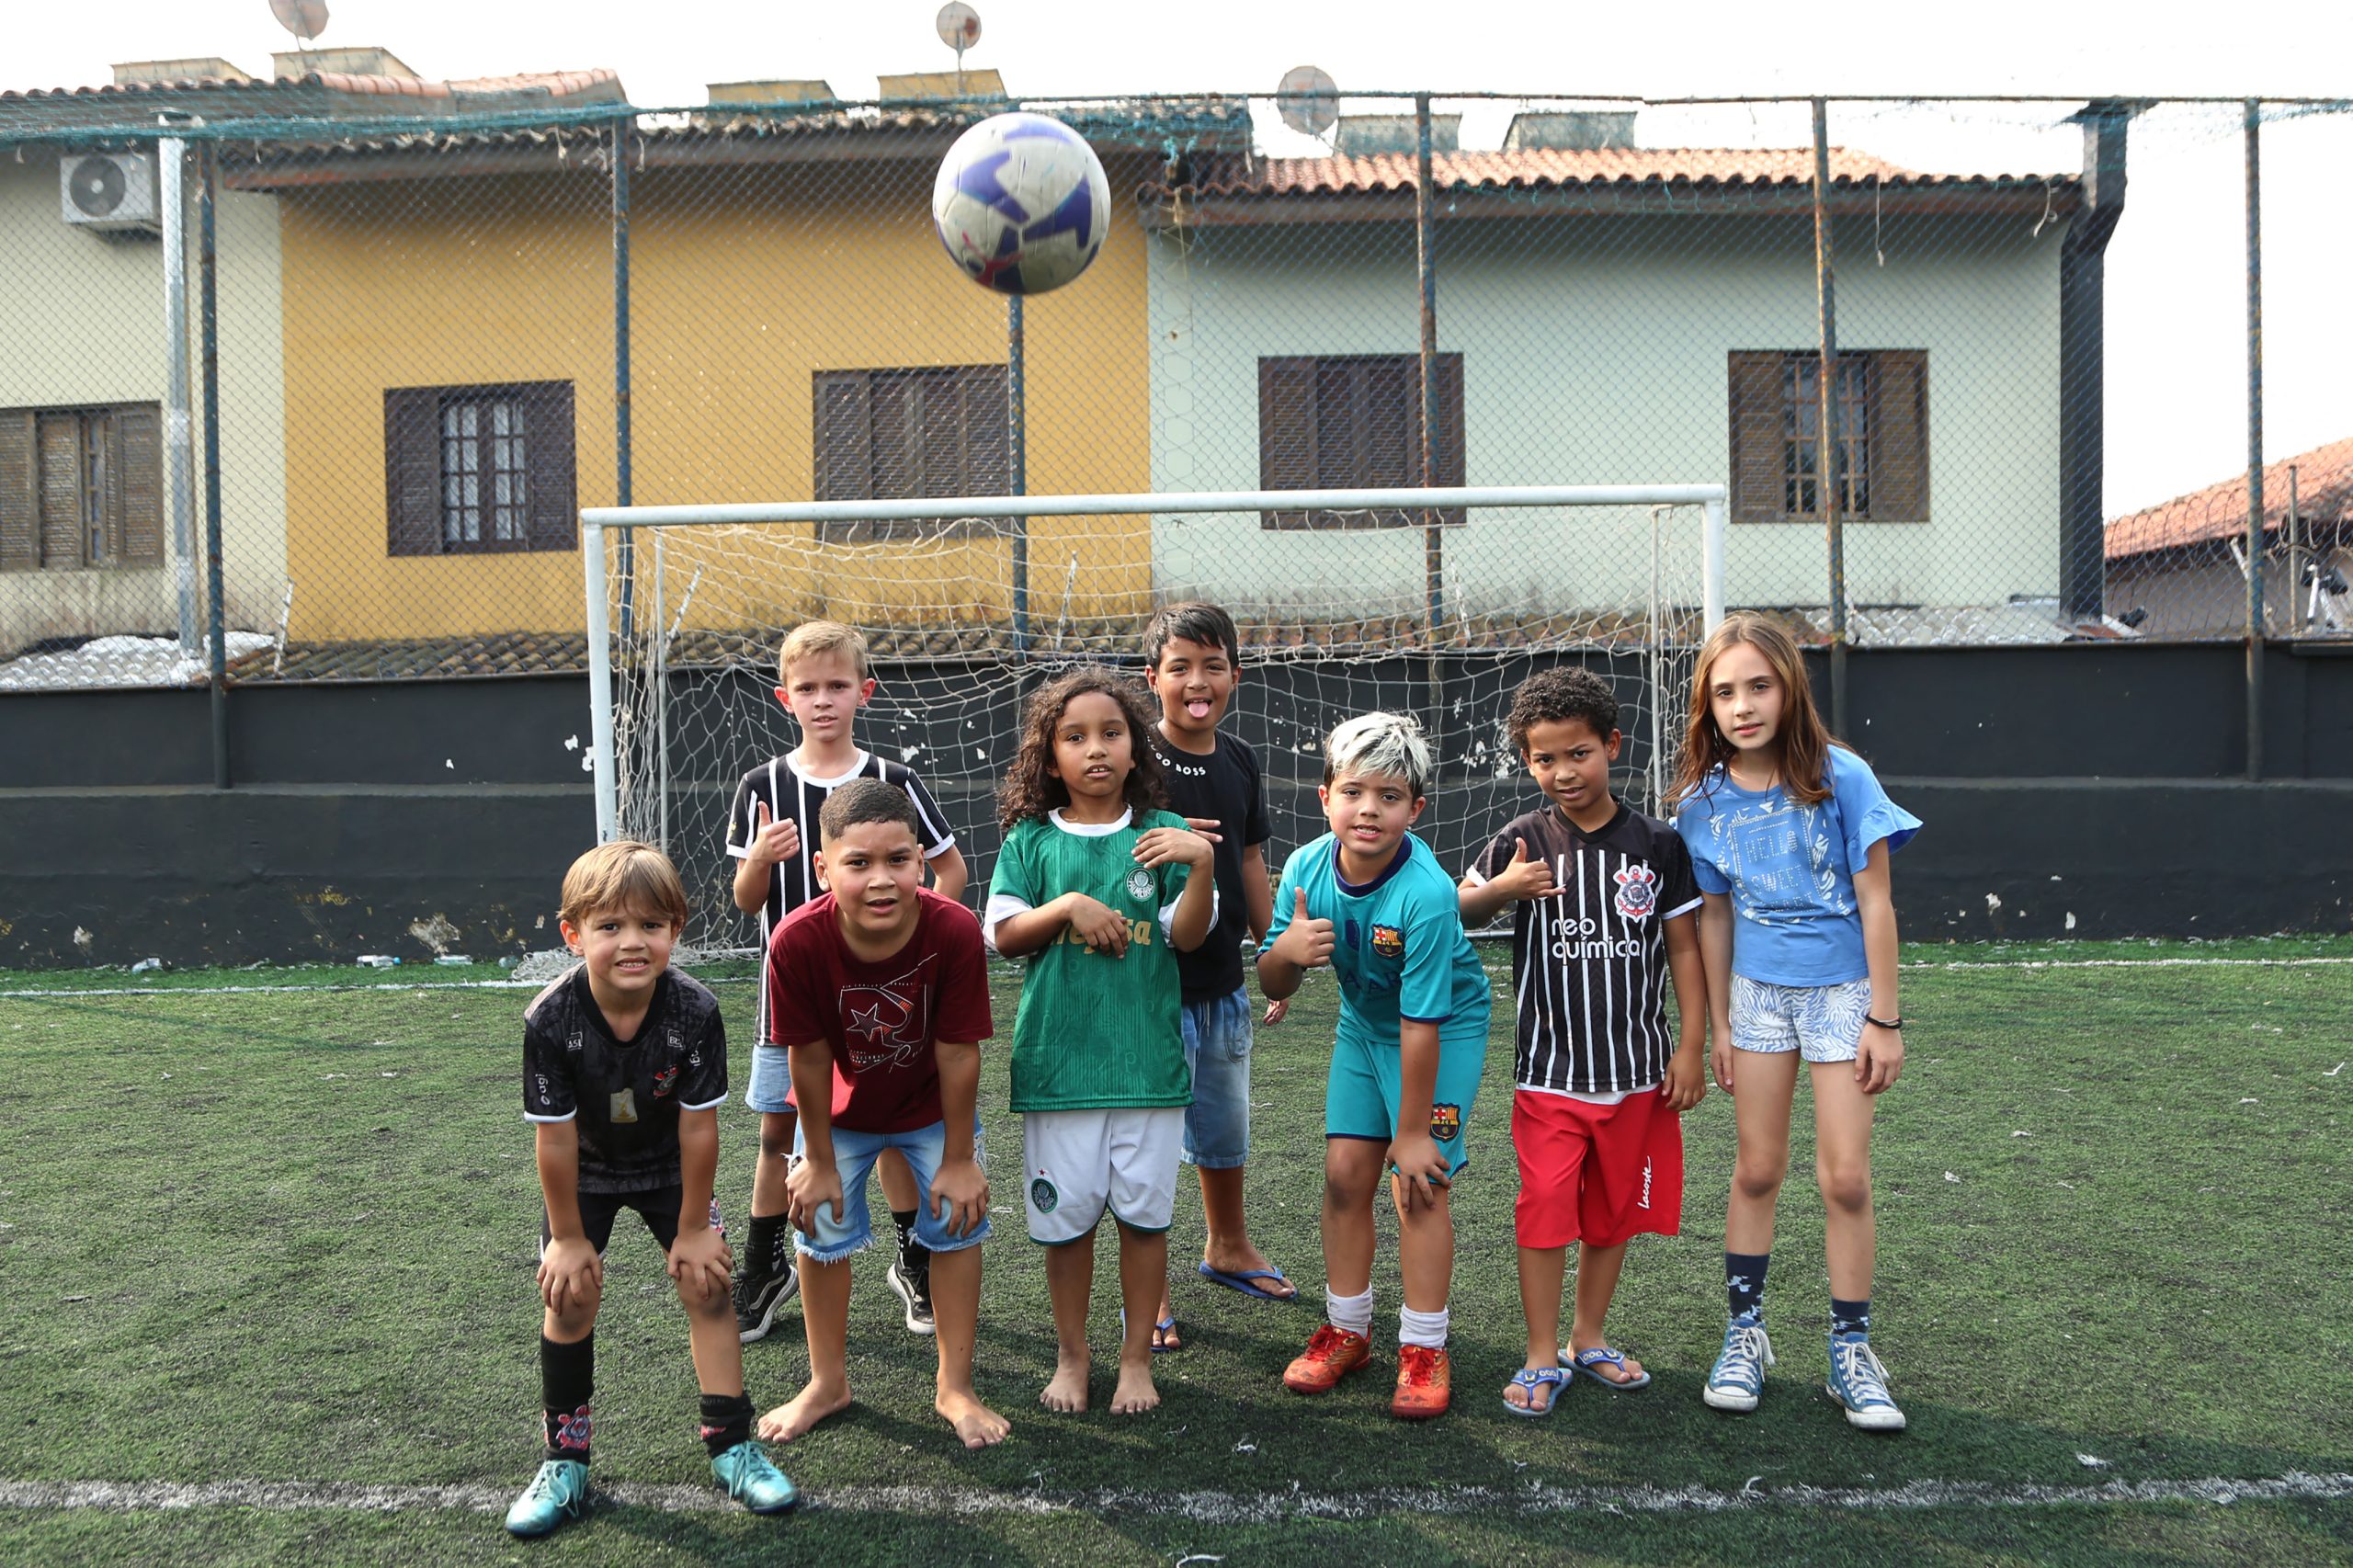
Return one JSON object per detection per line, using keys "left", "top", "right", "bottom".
{"left": 1259, "top": 713, "right": 1492, "bottom": 1420}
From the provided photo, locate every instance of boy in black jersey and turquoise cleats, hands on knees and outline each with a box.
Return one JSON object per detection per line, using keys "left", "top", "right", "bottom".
{"left": 506, "top": 840, "right": 798, "bottom": 1535}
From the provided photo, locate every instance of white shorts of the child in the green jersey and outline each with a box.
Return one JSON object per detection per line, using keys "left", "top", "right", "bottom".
{"left": 1021, "top": 1104, "right": 1184, "bottom": 1245}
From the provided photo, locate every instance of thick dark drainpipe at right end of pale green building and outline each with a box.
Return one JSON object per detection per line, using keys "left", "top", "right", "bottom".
{"left": 2059, "top": 99, "right": 2134, "bottom": 621}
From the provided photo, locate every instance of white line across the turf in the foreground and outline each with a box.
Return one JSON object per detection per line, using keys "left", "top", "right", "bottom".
{"left": 0, "top": 1471, "right": 2353, "bottom": 1523}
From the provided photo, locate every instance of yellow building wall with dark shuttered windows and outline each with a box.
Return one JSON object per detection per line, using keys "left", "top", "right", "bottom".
{"left": 282, "top": 163, "right": 1151, "bottom": 641}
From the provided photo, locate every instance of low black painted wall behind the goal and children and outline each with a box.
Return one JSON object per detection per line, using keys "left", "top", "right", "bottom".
{"left": 0, "top": 642, "right": 2353, "bottom": 968}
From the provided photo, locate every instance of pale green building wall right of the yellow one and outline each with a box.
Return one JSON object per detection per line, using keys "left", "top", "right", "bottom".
{"left": 1151, "top": 206, "right": 2062, "bottom": 612}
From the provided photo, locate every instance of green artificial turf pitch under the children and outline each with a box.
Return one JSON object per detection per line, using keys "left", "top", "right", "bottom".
{"left": 0, "top": 937, "right": 2353, "bottom": 1568}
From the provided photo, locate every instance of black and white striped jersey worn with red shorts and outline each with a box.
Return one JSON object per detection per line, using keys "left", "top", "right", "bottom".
{"left": 1468, "top": 805, "right": 1699, "bottom": 1097}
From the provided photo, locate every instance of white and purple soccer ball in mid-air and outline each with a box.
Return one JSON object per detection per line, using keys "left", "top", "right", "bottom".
{"left": 932, "top": 113, "right": 1110, "bottom": 294}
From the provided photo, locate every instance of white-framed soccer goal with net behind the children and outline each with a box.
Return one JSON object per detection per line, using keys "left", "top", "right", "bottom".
{"left": 581, "top": 485, "right": 1727, "bottom": 937}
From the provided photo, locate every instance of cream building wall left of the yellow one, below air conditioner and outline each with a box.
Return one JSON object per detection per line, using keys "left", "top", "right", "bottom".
{"left": 0, "top": 148, "right": 285, "bottom": 653}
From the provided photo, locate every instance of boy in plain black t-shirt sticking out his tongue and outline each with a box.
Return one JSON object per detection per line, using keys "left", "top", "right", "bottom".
{"left": 1143, "top": 603, "right": 1299, "bottom": 1351}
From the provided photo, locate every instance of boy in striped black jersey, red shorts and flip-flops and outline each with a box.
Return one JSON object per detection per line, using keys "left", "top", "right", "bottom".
{"left": 1459, "top": 668, "right": 1709, "bottom": 1415}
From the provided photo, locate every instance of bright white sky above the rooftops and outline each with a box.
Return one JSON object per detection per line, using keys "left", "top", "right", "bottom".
{"left": 0, "top": 0, "right": 2353, "bottom": 513}
